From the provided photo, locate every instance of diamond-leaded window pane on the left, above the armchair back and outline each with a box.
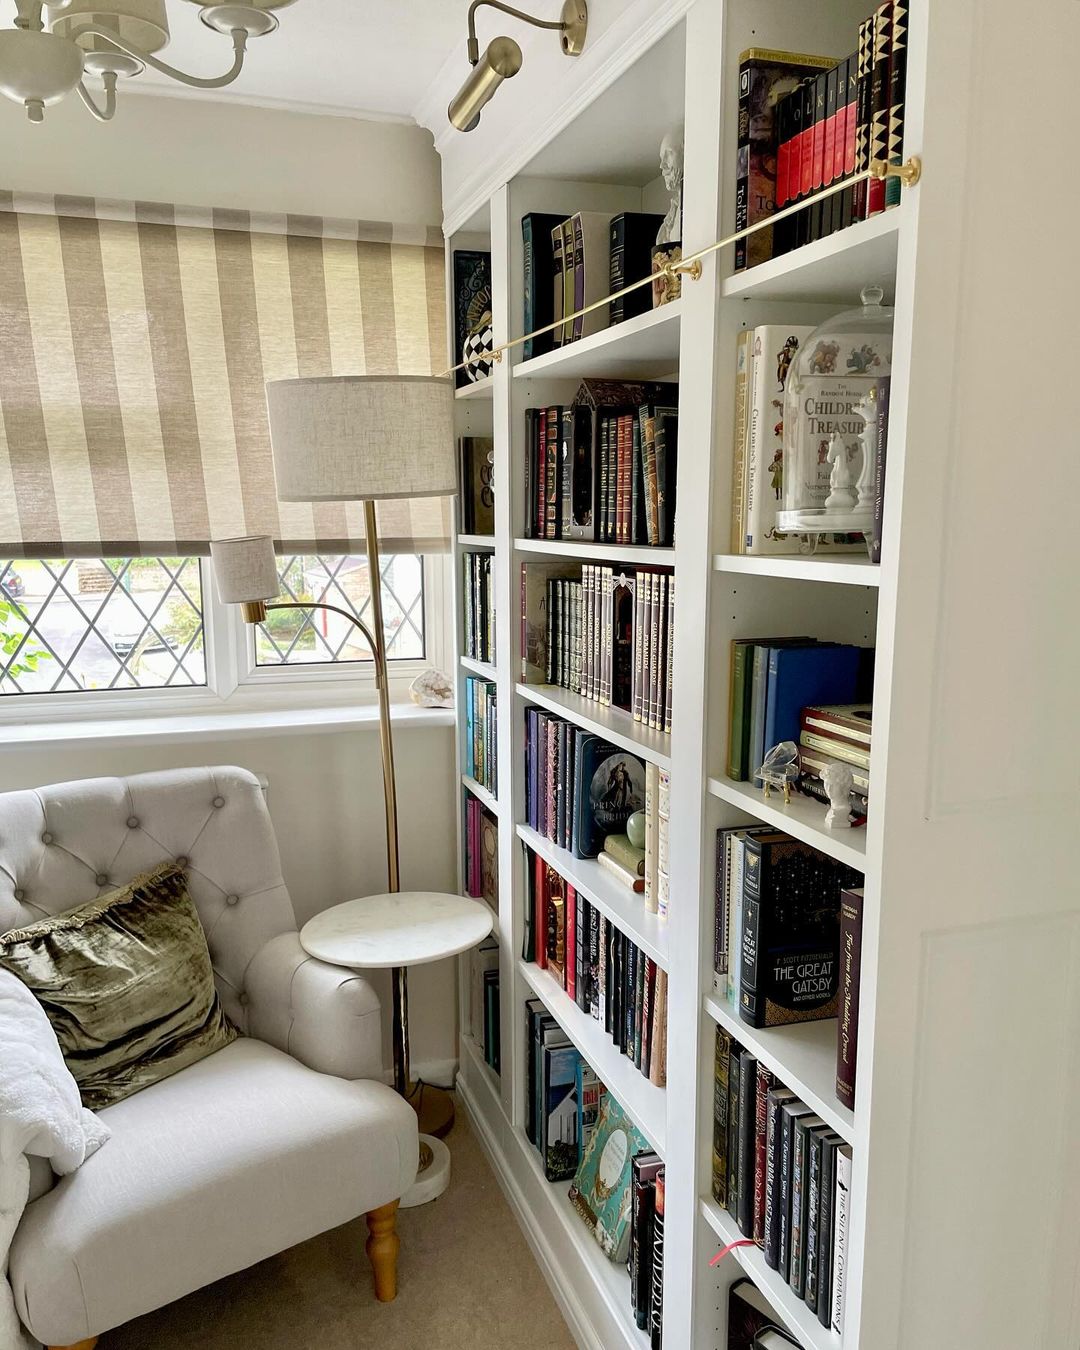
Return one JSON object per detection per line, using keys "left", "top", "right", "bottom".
{"left": 0, "top": 558, "right": 207, "bottom": 697}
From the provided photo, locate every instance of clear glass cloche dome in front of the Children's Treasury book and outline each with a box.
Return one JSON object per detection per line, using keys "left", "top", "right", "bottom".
{"left": 776, "top": 286, "right": 892, "bottom": 536}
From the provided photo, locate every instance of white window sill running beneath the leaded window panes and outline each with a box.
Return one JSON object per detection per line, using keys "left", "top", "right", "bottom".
{"left": 0, "top": 702, "right": 454, "bottom": 749}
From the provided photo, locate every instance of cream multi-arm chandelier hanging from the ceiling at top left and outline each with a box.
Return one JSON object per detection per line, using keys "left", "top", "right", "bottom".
{"left": 0, "top": 0, "right": 293, "bottom": 122}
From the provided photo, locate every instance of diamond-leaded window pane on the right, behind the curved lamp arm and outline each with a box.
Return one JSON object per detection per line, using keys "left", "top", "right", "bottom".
{"left": 255, "top": 554, "right": 424, "bottom": 666}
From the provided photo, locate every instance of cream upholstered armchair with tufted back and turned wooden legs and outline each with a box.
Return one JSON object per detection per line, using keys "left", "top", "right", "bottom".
{"left": 0, "top": 768, "right": 417, "bottom": 1347}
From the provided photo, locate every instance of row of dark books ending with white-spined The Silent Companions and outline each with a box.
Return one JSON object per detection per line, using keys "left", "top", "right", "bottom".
{"left": 713, "top": 1027, "right": 852, "bottom": 1334}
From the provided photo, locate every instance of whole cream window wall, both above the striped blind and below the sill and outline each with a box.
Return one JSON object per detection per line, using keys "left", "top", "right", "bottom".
{"left": 0, "top": 90, "right": 456, "bottom": 1068}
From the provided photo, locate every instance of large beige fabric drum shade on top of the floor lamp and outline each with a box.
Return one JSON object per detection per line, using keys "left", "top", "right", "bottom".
{"left": 266, "top": 375, "right": 458, "bottom": 502}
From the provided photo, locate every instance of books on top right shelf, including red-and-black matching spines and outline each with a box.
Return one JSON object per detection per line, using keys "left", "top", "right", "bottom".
{"left": 734, "top": 0, "right": 909, "bottom": 270}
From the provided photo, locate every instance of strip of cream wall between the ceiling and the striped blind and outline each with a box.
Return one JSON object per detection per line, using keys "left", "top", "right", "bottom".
{"left": 0, "top": 89, "right": 443, "bottom": 225}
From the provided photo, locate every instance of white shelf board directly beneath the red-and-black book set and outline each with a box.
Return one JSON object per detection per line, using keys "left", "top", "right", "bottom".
{"left": 720, "top": 203, "right": 907, "bottom": 305}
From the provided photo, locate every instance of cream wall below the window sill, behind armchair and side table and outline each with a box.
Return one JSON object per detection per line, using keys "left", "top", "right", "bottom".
{"left": 0, "top": 724, "right": 458, "bottom": 1073}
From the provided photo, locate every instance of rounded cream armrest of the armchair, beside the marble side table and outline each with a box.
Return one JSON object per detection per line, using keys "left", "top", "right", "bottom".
{"left": 244, "top": 933, "right": 382, "bottom": 1081}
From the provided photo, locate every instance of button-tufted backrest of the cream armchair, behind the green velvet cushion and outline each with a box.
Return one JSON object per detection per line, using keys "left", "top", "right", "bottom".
{"left": 0, "top": 768, "right": 296, "bottom": 1030}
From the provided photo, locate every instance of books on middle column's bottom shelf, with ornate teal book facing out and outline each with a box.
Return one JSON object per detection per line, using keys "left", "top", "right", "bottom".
{"left": 525, "top": 1015, "right": 664, "bottom": 1350}
